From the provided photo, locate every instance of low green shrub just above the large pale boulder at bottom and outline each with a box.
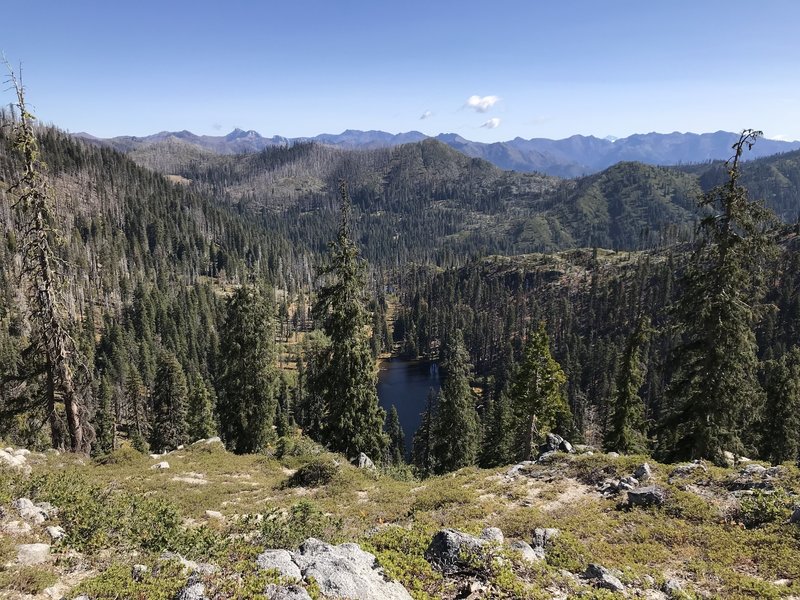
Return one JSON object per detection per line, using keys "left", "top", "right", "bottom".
{"left": 259, "top": 500, "right": 342, "bottom": 549}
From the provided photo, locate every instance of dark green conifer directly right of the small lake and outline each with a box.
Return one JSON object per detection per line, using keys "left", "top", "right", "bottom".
{"left": 433, "top": 329, "right": 480, "bottom": 473}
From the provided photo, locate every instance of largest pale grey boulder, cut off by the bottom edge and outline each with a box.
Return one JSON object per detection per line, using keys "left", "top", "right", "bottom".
{"left": 294, "top": 538, "right": 411, "bottom": 600}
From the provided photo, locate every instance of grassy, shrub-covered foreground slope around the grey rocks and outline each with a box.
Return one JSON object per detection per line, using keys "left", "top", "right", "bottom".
{"left": 0, "top": 438, "right": 800, "bottom": 600}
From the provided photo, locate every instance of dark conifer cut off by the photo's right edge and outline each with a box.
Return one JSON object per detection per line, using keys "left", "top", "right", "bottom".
{"left": 762, "top": 346, "right": 800, "bottom": 465}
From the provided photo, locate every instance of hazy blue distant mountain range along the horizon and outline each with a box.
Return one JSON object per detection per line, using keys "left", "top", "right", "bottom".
{"left": 75, "top": 129, "right": 800, "bottom": 177}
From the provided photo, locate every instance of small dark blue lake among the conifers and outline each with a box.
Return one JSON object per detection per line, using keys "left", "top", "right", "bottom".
{"left": 378, "top": 358, "right": 439, "bottom": 456}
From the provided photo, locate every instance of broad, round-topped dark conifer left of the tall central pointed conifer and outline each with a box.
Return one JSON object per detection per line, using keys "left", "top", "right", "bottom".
{"left": 217, "top": 286, "right": 277, "bottom": 454}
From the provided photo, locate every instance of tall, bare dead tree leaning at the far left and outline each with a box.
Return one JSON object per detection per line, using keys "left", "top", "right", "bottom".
{"left": 6, "top": 63, "right": 94, "bottom": 454}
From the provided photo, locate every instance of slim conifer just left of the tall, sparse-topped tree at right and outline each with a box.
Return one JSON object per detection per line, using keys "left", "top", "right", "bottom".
{"left": 603, "top": 319, "right": 650, "bottom": 454}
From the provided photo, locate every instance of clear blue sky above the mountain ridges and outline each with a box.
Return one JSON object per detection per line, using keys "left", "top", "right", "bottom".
{"left": 0, "top": 0, "right": 800, "bottom": 141}
